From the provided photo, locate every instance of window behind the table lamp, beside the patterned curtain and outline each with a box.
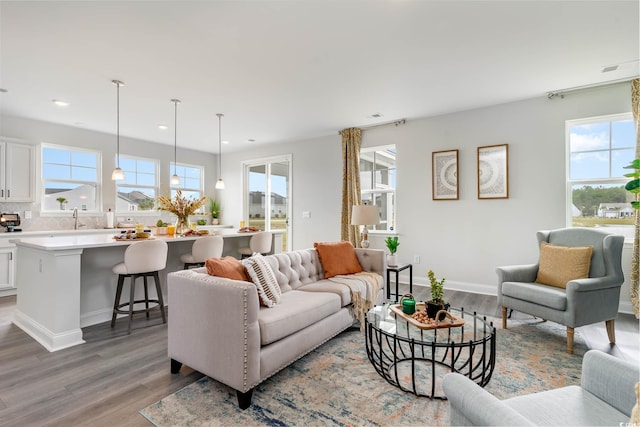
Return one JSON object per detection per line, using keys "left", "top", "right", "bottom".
{"left": 360, "top": 145, "right": 396, "bottom": 231}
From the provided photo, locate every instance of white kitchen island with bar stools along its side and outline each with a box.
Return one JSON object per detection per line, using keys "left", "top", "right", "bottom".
{"left": 12, "top": 230, "right": 283, "bottom": 351}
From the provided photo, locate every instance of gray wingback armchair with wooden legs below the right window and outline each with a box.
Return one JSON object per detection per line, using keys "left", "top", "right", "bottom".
{"left": 496, "top": 228, "right": 624, "bottom": 353}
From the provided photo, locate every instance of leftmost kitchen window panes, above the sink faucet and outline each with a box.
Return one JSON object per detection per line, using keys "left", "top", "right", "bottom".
{"left": 41, "top": 144, "right": 102, "bottom": 212}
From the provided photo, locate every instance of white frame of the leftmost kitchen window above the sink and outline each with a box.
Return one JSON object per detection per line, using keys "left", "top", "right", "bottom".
{"left": 39, "top": 142, "right": 102, "bottom": 216}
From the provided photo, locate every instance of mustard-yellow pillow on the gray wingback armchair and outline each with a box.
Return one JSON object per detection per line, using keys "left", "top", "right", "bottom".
{"left": 536, "top": 242, "right": 593, "bottom": 288}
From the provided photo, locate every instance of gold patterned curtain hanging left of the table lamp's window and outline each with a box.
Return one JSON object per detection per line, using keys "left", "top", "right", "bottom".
{"left": 340, "top": 128, "right": 362, "bottom": 247}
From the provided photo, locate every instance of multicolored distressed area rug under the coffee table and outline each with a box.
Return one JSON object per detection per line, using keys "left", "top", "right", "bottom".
{"left": 140, "top": 318, "right": 587, "bottom": 427}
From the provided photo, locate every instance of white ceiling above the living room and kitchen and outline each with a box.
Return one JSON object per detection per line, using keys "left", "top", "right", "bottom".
{"left": 0, "top": 0, "right": 640, "bottom": 152}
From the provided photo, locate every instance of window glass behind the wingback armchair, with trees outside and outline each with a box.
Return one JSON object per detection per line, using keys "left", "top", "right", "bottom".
{"left": 567, "top": 114, "right": 636, "bottom": 236}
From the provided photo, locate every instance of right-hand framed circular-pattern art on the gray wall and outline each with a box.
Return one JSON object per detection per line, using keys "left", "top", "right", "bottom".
{"left": 478, "top": 144, "right": 509, "bottom": 199}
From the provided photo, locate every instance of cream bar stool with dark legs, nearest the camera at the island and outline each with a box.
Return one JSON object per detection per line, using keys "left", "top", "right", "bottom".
{"left": 111, "top": 240, "right": 168, "bottom": 334}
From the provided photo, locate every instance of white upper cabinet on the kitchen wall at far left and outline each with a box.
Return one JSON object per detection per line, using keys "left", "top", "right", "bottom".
{"left": 0, "top": 141, "right": 36, "bottom": 202}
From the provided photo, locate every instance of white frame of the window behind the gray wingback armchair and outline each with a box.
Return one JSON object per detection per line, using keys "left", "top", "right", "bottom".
{"left": 565, "top": 112, "right": 634, "bottom": 234}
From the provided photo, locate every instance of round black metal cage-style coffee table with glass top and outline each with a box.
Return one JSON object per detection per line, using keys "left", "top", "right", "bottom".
{"left": 365, "top": 304, "right": 496, "bottom": 399}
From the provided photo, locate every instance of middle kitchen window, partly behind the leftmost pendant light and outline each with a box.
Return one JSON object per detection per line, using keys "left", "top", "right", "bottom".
{"left": 116, "top": 155, "right": 158, "bottom": 212}
